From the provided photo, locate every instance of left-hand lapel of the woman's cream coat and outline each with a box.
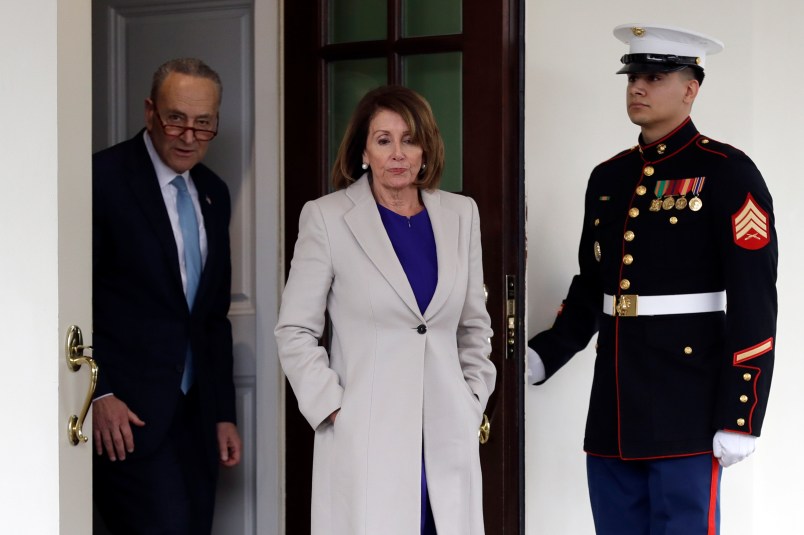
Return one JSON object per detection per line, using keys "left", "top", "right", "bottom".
{"left": 344, "top": 177, "right": 422, "bottom": 318}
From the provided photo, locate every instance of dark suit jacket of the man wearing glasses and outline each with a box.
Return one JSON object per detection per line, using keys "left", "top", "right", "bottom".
{"left": 92, "top": 131, "right": 235, "bottom": 472}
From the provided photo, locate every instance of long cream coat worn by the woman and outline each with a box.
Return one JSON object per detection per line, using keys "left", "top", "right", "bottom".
{"left": 275, "top": 175, "right": 496, "bottom": 535}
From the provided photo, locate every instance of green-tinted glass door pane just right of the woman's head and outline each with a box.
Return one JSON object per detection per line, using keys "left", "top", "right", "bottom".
{"left": 403, "top": 52, "right": 463, "bottom": 192}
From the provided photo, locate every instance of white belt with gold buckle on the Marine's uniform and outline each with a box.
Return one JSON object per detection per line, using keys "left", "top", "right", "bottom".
{"left": 603, "top": 290, "right": 726, "bottom": 317}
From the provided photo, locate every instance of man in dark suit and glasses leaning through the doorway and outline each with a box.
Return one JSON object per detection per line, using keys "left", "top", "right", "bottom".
{"left": 92, "top": 59, "right": 241, "bottom": 535}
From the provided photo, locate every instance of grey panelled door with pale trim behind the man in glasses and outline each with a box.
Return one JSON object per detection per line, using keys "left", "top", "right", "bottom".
{"left": 92, "top": 0, "right": 283, "bottom": 535}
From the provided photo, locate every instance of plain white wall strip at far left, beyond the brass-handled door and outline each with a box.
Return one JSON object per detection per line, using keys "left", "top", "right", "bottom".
{"left": 0, "top": 1, "right": 59, "bottom": 533}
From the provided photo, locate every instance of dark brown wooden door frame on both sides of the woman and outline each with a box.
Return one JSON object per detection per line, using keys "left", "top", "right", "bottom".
{"left": 282, "top": 0, "right": 525, "bottom": 534}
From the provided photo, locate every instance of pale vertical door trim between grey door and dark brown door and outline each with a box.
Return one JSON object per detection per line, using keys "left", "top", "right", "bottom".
{"left": 254, "top": 0, "right": 285, "bottom": 535}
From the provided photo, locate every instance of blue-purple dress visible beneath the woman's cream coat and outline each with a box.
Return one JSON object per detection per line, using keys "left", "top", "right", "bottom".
{"left": 377, "top": 204, "right": 438, "bottom": 535}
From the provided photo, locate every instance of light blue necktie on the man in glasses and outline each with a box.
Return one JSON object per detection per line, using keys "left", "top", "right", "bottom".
{"left": 170, "top": 175, "right": 201, "bottom": 394}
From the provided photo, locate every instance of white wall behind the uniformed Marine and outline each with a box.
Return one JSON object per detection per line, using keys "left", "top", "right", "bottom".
{"left": 525, "top": 0, "right": 804, "bottom": 535}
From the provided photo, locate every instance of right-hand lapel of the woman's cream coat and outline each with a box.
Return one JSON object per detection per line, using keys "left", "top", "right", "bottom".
{"left": 422, "top": 190, "right": 459, "bottom": 319}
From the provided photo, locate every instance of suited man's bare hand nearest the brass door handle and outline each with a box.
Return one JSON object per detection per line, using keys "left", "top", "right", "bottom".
{"left": 92, "top": 395, "right": 145, "bottom": 461}
